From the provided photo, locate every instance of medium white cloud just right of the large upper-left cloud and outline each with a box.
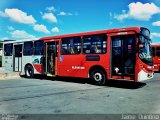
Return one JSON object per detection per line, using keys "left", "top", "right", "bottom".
{"left": 42, "top": 13, "right": 57, "bottom": 23}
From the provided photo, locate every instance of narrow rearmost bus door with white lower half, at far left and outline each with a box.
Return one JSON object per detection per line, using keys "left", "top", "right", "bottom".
{"left": 13, "top": 44, "right": 22, "bottom": 72}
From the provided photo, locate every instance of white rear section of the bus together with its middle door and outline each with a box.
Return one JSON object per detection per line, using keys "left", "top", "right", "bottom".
{"left": 2, "top": 40, "right": 58, "bottom": 78}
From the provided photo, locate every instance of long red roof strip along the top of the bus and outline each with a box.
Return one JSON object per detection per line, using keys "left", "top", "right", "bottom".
{"left": 40, "top": 26, "right": 144, "bottom": 40}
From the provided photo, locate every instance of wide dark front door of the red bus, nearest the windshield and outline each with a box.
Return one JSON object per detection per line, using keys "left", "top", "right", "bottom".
{"left": 111, "top": 35, "right": 136, "bottom": 80}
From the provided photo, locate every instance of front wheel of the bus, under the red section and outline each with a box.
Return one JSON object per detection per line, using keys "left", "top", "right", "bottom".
{"left": 90, "top": 70, "right": 106, "bottom": 86}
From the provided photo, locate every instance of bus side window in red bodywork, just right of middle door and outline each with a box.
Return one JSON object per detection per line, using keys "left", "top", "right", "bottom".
{"left": 61, "top": 37, "right": 81, "bottom": 55}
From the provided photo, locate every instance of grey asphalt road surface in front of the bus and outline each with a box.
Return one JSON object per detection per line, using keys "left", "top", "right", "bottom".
{"left": 0, "top": 73, "right": 160, "bottom": 114}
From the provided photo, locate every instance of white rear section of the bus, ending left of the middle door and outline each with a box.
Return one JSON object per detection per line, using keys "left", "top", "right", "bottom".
{"left": 2, "top": 40, "right": 44, "bottom": 77}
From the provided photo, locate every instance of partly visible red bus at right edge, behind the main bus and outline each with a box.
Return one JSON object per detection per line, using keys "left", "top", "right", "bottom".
{"left": 151, "top": 44, "right": 160, "bottom": 71}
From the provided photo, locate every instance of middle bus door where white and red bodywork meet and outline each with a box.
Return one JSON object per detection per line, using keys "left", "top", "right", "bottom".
{"left": 44, "top": 41, "right": 58, "bottom": 76}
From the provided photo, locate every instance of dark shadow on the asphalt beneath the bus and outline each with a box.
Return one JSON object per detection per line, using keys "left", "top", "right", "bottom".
{"left": 26, "top": 75, "right": 146, "bottom": 89}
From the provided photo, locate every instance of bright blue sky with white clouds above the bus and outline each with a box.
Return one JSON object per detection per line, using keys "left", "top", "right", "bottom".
{"left": 0, "top": 0, "right": 160, "bottom": 43}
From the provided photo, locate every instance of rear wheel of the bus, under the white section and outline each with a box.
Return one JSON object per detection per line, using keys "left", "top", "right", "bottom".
{"left": 25, "top": 65, "right": 34, "bottom": 78}
